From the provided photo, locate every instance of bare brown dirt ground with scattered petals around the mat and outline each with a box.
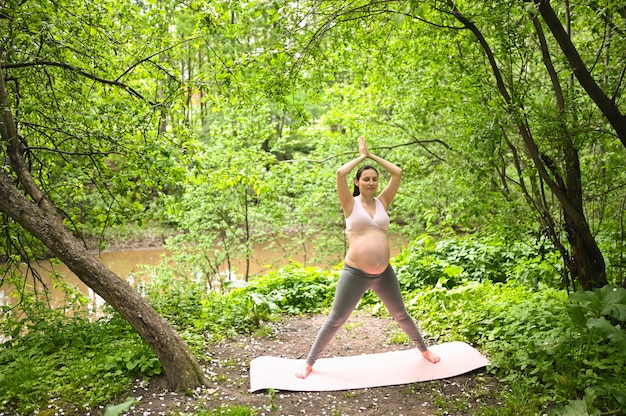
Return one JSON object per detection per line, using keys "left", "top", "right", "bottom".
{"left": 108, "top": 311, "right": 498, "bottom": 416}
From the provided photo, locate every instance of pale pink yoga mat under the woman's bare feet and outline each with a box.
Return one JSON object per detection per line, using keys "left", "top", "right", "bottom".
{"left": 250, "top": 342, "right": 489, "bottom": 391}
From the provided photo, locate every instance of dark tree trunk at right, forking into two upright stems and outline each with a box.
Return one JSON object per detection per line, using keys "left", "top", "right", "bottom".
{"left": 448, "top": 1, "right": 619, "bottom": 290}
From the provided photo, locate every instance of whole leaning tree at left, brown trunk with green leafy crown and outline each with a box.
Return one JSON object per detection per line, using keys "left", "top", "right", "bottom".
{"left": 0, "top": 0, "right": 206, "bottom": 389}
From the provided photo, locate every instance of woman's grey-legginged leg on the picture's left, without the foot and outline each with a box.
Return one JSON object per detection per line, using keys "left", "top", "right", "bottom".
{"left": 306, "top": 266, "right": 375, "bottom": 366}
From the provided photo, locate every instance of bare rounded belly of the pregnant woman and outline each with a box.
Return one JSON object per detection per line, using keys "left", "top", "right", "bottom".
{"left": 345, "top": 228, "right": 390, "bottom": 274}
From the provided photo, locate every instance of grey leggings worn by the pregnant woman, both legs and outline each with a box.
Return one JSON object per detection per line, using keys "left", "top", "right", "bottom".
{"left": 306, "top": 265, "right": 427, "bottom": 365}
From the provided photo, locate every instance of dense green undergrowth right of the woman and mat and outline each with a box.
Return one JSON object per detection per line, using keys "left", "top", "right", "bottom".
{"left": 388, "top": 237, "right": 626, "bottom": 414}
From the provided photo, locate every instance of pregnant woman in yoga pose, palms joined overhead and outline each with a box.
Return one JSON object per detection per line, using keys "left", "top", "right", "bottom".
{"left": 296, "top": 137, "right": 440, "bottom": 378}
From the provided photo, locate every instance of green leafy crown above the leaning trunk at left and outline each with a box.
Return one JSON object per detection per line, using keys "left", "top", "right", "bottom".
{"left": 0, "top": 0, "right": 194, "bottom": 259}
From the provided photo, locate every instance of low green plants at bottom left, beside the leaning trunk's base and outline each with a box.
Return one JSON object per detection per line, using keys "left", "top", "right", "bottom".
{"left": 0, "top": 308, "right": 161, "bottom": 413}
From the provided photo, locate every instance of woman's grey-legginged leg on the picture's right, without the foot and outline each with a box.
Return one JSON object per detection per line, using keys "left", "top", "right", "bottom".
{"left": 371, "top": 265, "right": 428, "bottom": 352}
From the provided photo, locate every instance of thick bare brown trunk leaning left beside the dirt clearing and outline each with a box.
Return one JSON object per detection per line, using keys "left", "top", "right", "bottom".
{"left": 0, "top": 71, "right": 207, "bottom": 390}
